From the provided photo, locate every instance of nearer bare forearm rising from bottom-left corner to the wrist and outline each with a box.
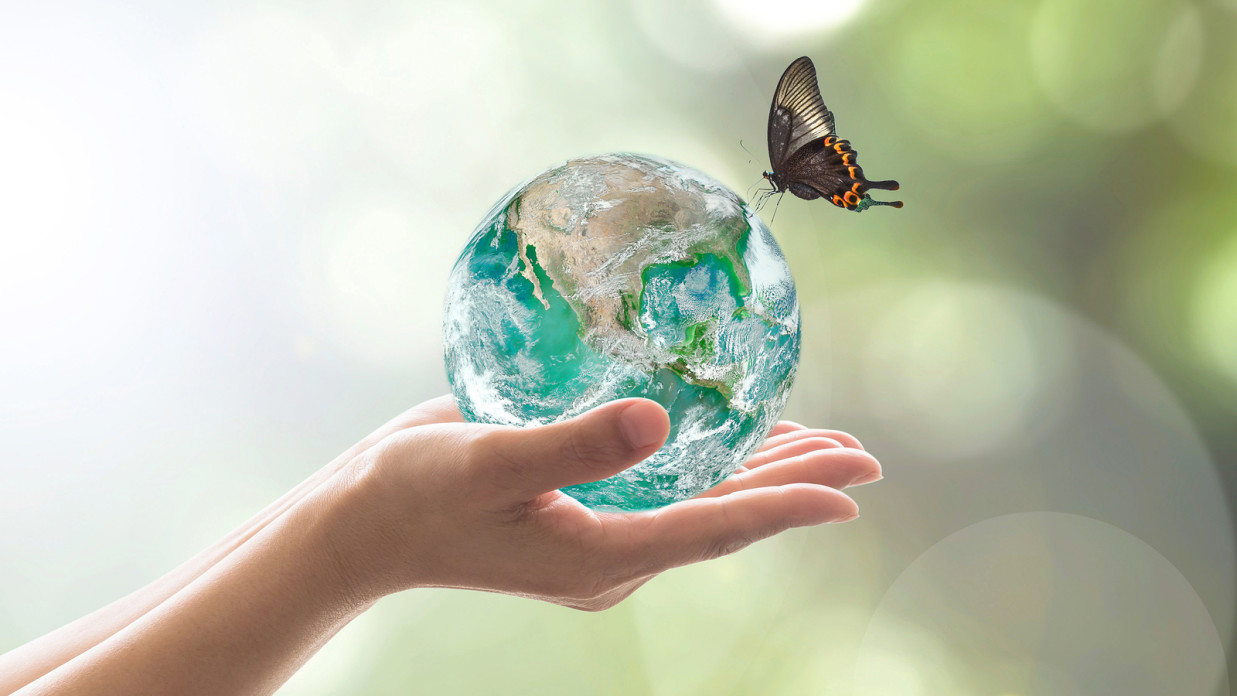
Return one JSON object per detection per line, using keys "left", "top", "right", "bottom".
{"left": 17, "top": 486, "right": 367, "bottom": 696}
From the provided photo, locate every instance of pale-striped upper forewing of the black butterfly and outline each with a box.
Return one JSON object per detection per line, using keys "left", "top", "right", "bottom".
{"left": 768, "top": 56, "right": 834, "bottom": 174}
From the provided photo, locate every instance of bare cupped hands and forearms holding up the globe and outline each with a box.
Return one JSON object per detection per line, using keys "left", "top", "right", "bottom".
{"left": 0, "top": 397, "right": 881, "bottom": 696}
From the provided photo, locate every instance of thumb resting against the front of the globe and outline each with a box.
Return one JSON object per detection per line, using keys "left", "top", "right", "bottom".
{"left": 477, "top": 399, "right": 670, "bottom": 501}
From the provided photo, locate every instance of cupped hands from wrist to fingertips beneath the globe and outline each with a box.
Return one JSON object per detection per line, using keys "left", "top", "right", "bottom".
{"left": 330, "top": 397, "right": 881, "bottom": 611}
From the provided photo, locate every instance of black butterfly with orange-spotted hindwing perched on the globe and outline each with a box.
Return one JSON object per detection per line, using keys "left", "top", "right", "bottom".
{"left": 761, "top": 56, "right": 902, "bottom": 213}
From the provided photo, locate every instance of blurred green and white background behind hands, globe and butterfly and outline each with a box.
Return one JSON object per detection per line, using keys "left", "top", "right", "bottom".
{"left": 0, "top": 0, "right": 1237, "bottom": 696}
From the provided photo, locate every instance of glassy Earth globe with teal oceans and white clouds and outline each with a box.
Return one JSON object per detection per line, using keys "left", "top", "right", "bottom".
{"left": 443, "top": 153, "right": 799, "bottom": 511}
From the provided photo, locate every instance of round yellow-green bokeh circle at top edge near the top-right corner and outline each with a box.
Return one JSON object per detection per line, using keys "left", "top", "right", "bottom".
{"left": 1030, "top": 0, "right": 1202, "bottom": 132}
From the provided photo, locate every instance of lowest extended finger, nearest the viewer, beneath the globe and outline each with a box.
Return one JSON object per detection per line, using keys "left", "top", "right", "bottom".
{"left": 616, "top": 483, "right": 858, "bottom": 576}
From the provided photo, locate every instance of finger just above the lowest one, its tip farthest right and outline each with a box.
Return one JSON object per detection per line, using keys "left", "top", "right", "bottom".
{"left": 700, "top": 448, "right": 881, "bottom": 498}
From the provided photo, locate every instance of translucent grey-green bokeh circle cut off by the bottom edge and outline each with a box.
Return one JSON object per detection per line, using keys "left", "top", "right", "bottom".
{"left": 854, "top": 512, "right": 1227, "bottom": 696}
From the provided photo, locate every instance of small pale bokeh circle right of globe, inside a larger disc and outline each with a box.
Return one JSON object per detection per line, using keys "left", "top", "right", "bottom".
{"left": 852, "top": 282, "right": 1070, "bottom": 461}
